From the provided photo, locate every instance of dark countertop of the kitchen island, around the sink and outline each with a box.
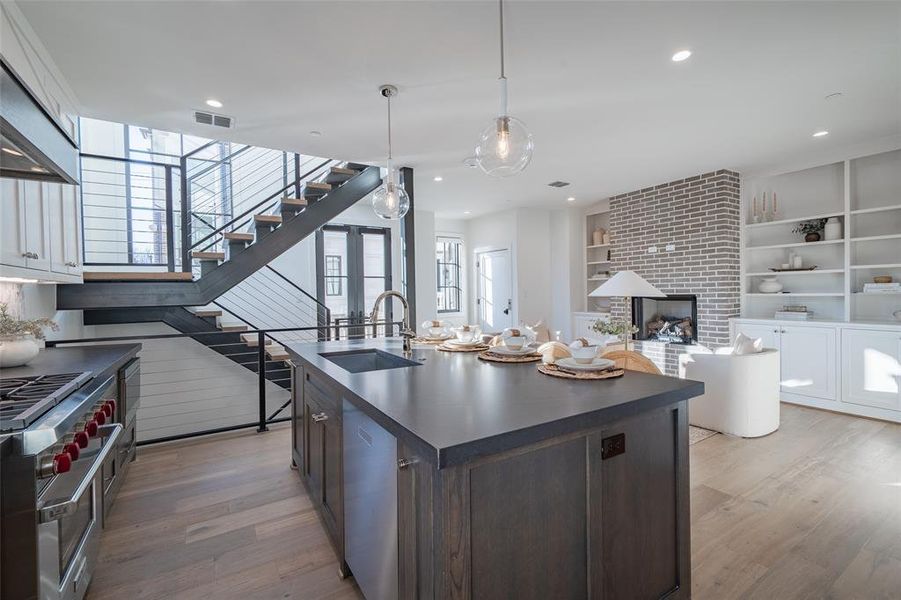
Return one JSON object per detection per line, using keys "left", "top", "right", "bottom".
{"left": 287, "top": 339, "right": 704, "bottom": 468}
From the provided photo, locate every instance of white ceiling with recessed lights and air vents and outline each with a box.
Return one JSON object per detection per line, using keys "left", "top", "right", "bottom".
{"left": 18, "top": 1, "right": 901, "bottom": 217}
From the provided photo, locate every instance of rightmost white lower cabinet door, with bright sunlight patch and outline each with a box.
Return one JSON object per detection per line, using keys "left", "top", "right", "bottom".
{"left": 842, "top": 329, "right": 901, "bottom": 410}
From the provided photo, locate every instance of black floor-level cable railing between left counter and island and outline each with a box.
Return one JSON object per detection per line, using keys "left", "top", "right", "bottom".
{"left": 46, "top": 321, "right": 401, "bottom": 445}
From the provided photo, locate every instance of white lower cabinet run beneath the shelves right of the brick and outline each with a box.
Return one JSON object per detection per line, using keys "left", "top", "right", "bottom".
{"left": 732, "top": 319, "right": 901, "bottom": 422}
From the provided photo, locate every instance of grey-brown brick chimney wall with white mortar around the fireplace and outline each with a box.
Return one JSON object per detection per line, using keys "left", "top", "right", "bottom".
{"left": 610, "top": 170, "right": 741, "bottom": 375}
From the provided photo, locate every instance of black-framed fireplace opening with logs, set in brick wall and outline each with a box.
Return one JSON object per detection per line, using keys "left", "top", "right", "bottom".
{"left": 632, "top": 294, "right": 698, "bottom": 344}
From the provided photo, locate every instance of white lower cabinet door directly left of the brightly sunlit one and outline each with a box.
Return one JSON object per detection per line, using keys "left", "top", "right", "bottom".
{"left": 780, "top": 325, "right": 837, "bottom": 400}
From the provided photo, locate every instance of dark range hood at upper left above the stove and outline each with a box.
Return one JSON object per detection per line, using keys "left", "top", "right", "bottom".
{"left": 0, "top": 59, "right": 78, "bottom": 184}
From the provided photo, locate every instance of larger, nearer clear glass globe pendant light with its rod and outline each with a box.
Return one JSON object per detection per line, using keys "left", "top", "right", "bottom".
{"left": 476, "top": 0, "right": 534, "bottom": 177}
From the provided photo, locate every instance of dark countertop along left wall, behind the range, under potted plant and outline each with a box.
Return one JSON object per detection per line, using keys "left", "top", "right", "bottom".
{"left": 0, "top": 344, "right": 141, "bottom": 379}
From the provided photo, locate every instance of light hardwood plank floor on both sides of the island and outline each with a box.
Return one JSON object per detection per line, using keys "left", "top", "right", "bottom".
{"left": 88, "top": 405, "right": 901, "bottom": 600}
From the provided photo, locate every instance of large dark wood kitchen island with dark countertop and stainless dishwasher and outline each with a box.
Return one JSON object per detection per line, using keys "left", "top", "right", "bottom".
{"left": 288, "top": 340, "right": 703, "bottom": 600}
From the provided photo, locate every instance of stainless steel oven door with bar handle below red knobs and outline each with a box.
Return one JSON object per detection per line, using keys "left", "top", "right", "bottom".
{"left": 38, "top": 423, "right": 124, "bottom": 600}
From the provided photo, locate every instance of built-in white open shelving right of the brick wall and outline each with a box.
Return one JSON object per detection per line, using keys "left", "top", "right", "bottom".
{"left": 741, "top": 150, "right": 901, "bottom": 323}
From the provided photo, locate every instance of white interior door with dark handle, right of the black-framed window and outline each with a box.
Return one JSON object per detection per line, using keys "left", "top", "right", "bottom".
{"left": 476, "top": 250, "right": 513, "bottom": 333}
